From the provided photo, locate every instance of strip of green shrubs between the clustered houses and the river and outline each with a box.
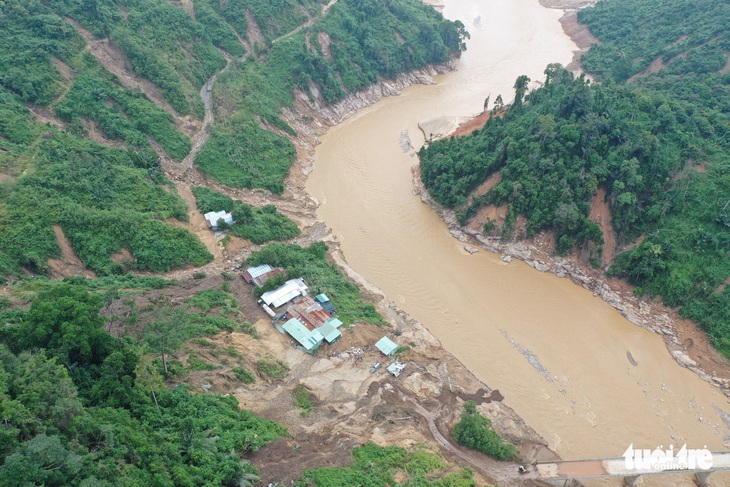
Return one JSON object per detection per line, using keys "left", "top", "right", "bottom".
{"left": 248, "top": 242, "right": 383, "bottom": 324}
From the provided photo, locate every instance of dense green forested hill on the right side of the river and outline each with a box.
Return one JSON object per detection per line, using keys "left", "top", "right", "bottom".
{"left": 420, "top": 0, "right": 730, "bottom": 356}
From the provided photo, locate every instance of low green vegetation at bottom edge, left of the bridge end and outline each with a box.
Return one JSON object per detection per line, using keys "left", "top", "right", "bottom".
{"left": 295, "top": 443, "right": 477, "bottom": 487}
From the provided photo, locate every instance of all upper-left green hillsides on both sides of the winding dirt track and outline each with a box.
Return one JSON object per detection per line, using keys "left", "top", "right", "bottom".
{"left": 0, "top": 0, "right": 465, "bottom": 279}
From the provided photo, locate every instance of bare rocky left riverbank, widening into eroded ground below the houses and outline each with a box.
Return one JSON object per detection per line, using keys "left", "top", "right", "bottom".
{"left": 155, "top": 61, "right": 559, "bottom": 485}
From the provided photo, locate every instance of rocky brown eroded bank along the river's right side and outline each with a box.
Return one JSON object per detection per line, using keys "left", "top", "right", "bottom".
{"left": 413, "top": 0, "right": 730, "bottom": 404}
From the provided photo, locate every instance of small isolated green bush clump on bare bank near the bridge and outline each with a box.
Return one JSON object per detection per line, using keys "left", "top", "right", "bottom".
{"left": 452, "top": 401, "right": 517, "bottom": 460}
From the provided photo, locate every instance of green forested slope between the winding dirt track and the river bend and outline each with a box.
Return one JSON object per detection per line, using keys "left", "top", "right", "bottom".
{"left": 196, "top": 0, "right": 466, "bottom": 193}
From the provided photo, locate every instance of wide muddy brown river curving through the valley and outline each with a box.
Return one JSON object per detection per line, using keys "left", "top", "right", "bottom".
{"left": 307, "top": 0, "right": 730, "bottom": 476}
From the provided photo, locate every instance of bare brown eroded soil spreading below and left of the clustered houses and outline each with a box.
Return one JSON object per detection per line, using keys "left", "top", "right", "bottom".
{"left": 111, "top": 273, "right": 544, "bottom": 485}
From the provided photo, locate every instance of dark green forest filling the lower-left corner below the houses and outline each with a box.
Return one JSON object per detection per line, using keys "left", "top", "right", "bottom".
{"left": 0, "top": 276, "right": 286, "bottom": 487}
